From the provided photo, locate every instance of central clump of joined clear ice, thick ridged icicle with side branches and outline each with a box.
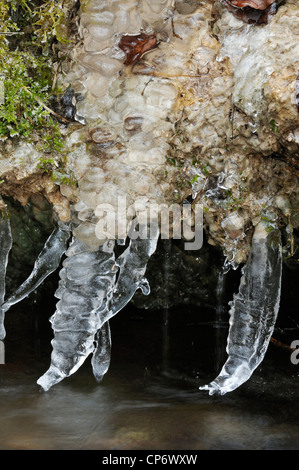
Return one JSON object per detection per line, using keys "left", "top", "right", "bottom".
{"left": 37, "top": 222, "right": 159, "bottom": 391}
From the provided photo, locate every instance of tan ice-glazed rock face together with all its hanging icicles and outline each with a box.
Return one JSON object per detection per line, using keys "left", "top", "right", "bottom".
{"left": 0, "top": 0, "right": 299, "bottom": 394}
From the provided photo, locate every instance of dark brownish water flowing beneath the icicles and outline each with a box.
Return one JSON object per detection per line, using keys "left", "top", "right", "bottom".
{"left": 0, "top": 307, "right": 299, "bottom": 450}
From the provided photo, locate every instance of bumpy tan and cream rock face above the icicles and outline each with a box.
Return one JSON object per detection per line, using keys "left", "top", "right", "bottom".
{"left": 0, "top": 0, "right": 299, "bottom": 268}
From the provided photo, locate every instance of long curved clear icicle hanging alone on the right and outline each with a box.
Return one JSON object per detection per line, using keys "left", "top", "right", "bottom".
{"left": 200, "top": 223, "right": 282, "bottom": 395}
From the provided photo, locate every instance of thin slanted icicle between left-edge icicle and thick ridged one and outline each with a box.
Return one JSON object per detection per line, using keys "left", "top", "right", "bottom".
{"left": 2, "top": 222, "right": 70, "bottom": 312}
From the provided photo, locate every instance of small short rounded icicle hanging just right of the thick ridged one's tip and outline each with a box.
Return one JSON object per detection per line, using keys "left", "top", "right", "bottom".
{"left": 91, "top": 322, "right": 111, "bottom": 382}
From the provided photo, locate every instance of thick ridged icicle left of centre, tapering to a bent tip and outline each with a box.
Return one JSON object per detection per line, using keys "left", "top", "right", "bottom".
{"left": 37, "top": 239, "right": 116, "bottom": 391}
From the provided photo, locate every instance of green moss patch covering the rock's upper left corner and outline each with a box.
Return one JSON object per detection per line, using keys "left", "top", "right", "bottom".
{"left": 0, "top": 0, "right": 76, "bottom": 184}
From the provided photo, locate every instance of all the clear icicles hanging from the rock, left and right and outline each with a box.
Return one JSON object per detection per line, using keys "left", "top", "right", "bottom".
{"left": 0, "top": 198, "right": 282, "bottom": 395}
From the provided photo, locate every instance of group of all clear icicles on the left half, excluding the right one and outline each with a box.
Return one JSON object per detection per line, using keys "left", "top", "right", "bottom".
{"left": 0, "top": 201, "right": 159, "bottom": 391}
